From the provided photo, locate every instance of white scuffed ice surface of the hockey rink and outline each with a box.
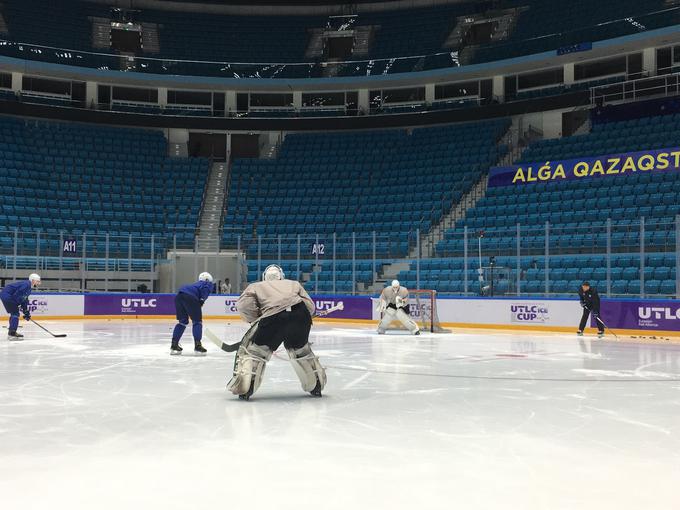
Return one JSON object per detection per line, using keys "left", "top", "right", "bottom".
{"left": 0, "top": 320, "right": 680, "bottom": 510}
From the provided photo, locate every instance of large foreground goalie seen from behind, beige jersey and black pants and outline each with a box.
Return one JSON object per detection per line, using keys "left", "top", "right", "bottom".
{"left": 227, "top": 264, "right": 326, "bottom": 400}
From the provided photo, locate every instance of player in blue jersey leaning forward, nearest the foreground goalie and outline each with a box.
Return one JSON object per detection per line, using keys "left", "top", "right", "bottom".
{"left": 170, "top": 273, "right": 213, "bottom": 355}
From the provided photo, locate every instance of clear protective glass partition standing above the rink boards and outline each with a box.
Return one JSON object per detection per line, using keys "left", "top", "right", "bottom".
{"left": 0, "top": 215, "right": 680, "bottom": 298}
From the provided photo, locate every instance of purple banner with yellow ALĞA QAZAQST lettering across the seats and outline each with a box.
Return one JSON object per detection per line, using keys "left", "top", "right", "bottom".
{"left": 489, "top": 148, "right": 680, "bottom": 187}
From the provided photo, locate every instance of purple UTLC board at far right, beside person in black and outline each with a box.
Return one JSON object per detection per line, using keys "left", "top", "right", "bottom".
{"left": 591, "top": 299, "right": 680, "bottom": 331}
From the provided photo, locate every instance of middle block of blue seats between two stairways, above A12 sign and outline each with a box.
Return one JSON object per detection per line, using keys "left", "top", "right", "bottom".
{"left": 223, "top": 119, "right": 510, "bottom": 291}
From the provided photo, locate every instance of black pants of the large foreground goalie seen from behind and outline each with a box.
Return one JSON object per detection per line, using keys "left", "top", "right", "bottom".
{"left": 253, "top": 303, "right": 312, "bottom": 351}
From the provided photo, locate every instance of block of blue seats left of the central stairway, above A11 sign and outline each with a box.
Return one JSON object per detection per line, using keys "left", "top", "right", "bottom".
{"left": 0, "top": 117, "right": 209, "bottom": 257}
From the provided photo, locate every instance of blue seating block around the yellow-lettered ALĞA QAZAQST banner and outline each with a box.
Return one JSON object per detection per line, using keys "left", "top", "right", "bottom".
{"left": 399, "top": 109, "right": 680, "bottom": 297}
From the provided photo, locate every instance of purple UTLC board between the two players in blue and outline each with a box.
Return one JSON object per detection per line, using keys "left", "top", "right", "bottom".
{"left": 85, "top": 294, "right": 175, "bottom": 315}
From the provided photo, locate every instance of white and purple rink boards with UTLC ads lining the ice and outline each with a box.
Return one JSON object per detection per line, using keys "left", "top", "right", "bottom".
{"left": 10, "top": 293, "right": 680, "bottom": 335}
